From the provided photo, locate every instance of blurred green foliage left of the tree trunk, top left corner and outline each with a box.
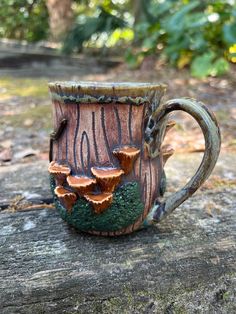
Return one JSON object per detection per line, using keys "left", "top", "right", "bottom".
{"left": 0, "top": 0, "right": 48, "bottom": 42}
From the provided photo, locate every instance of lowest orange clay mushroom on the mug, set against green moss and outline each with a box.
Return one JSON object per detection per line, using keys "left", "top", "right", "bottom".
{"left": 84, "top": 193, "right": 113, "bottom": 214}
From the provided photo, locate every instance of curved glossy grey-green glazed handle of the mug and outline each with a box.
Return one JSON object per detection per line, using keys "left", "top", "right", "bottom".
{"left": 144, "top": 98, "right": 221, "bottom": 226}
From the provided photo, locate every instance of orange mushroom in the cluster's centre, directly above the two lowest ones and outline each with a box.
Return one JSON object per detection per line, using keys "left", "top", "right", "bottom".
{"left": 66, "top": 175, "right": 96, "bottom": 196}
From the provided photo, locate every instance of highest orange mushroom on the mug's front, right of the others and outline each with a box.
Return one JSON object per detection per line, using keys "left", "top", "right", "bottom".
{"left": 113, "top": 146, "right": 140, "bottom": 175}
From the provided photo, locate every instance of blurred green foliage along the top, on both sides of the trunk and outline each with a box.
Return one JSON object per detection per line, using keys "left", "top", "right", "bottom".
{"left": 0, "top": 0, "right": 236, "bottom": 78}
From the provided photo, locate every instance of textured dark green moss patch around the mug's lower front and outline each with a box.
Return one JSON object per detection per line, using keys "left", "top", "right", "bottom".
{"left": 50, "top": 177, "right": 144, "bottom": 232}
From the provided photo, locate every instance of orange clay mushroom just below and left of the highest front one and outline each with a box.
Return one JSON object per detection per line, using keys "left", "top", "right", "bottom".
{"left": 91, "top": 167, "right": 124, "bottom": 193}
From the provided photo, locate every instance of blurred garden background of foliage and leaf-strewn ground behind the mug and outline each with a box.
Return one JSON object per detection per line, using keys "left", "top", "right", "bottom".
{"left": 0, "top": 0, "right": 236, "bottom": 209}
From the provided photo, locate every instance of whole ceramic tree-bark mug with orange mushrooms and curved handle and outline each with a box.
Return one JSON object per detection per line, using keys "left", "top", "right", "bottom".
{"left": 48, "top": 82, "right": 220, "bottom": 236}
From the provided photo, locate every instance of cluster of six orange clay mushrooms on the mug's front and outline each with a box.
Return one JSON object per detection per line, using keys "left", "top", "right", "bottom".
{"left": 48, "top": 146, "right": 140, "bottom": 214}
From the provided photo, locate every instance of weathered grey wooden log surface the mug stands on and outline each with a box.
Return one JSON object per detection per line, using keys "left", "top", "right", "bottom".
{"left": 0, "top": 155, "right": 236, "bottom": 314}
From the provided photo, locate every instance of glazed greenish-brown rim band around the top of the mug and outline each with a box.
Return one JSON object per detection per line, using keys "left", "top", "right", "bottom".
{"left": 48, "top": 81, "right": 167, "bottom": 105}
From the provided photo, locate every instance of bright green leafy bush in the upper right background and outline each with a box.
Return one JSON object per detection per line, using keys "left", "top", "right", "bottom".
{"left": 126, "top": 0, "right": 236, "bottom": 77}
